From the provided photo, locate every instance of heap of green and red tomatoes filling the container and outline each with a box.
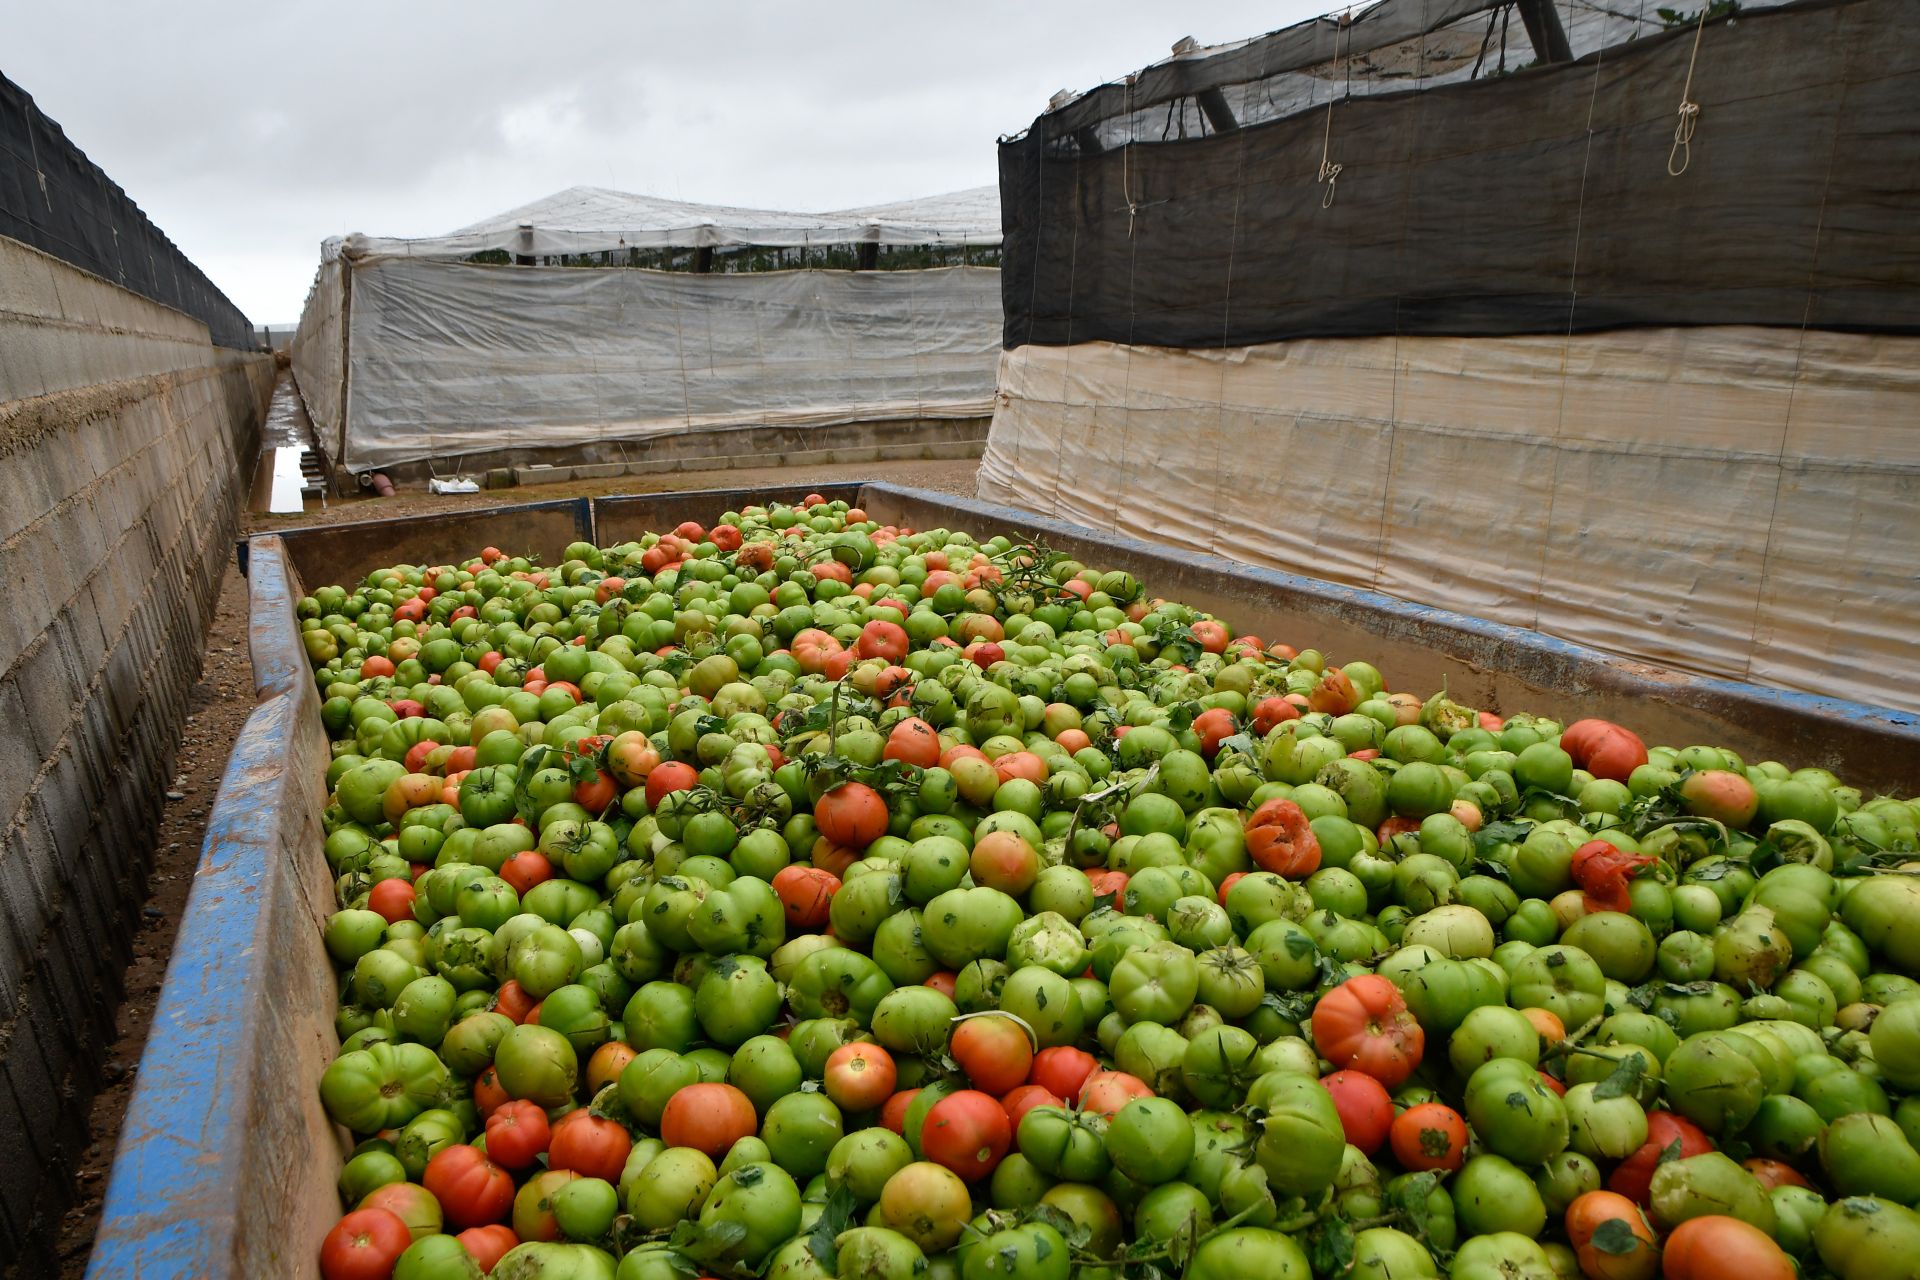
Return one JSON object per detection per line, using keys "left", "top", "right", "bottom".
{"left": 300, "top": 499, "right": 1920, "bottom": 1280}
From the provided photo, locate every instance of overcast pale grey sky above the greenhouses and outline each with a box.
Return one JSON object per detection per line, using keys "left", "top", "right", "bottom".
{"left": 0, "top": 0, "right": 1327, "bottom": 324}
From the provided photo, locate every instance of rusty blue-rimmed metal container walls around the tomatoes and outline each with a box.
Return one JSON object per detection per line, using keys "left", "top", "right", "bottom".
{"left": 86, "top": 484, "right": 1920, "bottom": 1280}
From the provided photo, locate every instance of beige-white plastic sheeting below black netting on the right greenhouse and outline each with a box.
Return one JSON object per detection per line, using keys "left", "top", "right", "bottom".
{"left": 979, "top": 328, "right": 1920, "bottom": 710}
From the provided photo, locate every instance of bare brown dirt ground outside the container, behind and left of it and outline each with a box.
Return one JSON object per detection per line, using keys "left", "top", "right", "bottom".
{"left": 60, "top": 461, "right": 977, "bottom": 1280}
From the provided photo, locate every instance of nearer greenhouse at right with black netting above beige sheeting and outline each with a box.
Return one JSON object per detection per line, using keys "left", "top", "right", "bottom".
{"left": 979, "top": 0, "right": 1920, "bottom": 708}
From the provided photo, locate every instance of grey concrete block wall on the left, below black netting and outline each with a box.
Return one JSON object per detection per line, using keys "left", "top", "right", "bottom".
{"left": 0, "top": 238, "right": 273, "bottom": 1274}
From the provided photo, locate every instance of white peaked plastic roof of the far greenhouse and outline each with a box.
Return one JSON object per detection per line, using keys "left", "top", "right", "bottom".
{"left": 338, "top": 186, "right": 1000, "bottom": 259}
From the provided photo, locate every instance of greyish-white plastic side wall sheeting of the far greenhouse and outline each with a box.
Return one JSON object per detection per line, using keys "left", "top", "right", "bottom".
{"left": 307, "top": 257, "right": 1000, "bottom": 472}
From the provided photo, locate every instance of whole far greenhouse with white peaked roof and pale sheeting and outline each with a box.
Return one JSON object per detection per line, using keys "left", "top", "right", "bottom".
{"left": 292, "top": 186, "right": 1000, "bottom": 478}
